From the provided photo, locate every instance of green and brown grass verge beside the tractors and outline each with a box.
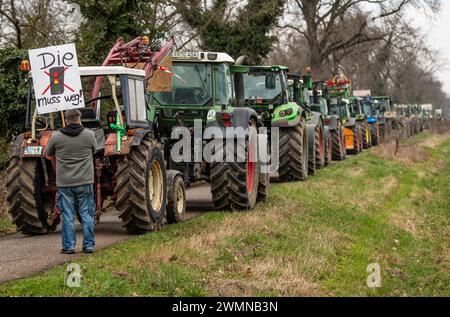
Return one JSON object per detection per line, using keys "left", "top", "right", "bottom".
{"left": 0, "top": 134, "right": 450, "bottom": 296}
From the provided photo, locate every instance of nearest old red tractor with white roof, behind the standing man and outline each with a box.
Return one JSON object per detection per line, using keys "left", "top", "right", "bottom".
{"left": 7, "top": 37, "right": 186, "bottom": 235}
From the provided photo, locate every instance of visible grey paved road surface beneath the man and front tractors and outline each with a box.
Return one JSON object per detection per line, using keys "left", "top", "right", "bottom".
{"left": 0, "top": 185, "right": 212, "bottom": 283}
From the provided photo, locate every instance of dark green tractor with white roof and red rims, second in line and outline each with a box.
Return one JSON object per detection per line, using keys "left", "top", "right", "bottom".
{"left": 148, "top": 52, "right": 269, "bottom": 210}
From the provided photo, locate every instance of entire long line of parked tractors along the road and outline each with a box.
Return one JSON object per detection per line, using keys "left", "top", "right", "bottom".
{"left": 7, "top": 37, "right": 440, "bottom": 235}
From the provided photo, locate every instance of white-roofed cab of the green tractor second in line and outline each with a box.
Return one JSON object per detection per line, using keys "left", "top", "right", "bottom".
{"left": 148, "top": 52, "right": 243, "bottom": 137}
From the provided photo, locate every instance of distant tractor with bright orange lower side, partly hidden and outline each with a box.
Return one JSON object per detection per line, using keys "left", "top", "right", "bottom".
{"left": 327, "top": 74, "right": 363, "bottom": 154}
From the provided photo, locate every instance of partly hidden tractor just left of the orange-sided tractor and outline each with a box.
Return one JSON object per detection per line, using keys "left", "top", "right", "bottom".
{"left": 309, "top": 81, "right": 347, "bottom": 160}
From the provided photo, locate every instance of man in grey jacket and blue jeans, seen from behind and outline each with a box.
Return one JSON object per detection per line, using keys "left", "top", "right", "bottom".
{"left": 46, "top": 109, "right": 97, "bottom": 254}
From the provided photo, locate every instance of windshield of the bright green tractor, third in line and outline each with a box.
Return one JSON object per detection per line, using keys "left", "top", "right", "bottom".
{"left": 244, "top": 72, "right": 283, "bottom": 100}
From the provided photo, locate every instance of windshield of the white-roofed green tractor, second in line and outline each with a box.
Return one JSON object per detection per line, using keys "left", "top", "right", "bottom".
{"left": 153, "top": 63, "right": 213, "bottom": 106}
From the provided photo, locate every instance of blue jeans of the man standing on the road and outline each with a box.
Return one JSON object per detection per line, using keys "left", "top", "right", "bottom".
{"left": 58, "top": 185, "right": 95, "bottom": 251}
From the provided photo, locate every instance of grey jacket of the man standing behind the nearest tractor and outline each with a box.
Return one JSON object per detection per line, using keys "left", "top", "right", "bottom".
{"left": 46, "top": 125, "right": 97, "bottom": 187}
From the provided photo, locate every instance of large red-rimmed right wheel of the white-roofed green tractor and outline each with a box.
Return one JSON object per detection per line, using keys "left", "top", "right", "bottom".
{"left": 210, "top": 122, "right": 259, "bottom": 210}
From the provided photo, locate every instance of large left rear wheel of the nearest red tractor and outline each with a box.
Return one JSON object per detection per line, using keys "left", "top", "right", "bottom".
{"left": 6, "top": 157, "right": 60, "bottom": 235}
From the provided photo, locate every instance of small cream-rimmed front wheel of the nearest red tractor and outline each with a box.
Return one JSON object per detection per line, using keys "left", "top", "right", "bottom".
{"left": 166, "top": 171, "right": 186, "bottom": 224}
